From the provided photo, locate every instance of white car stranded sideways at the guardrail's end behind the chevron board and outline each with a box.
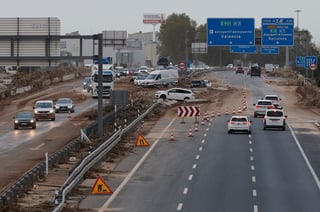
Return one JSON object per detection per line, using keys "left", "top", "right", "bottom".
{"left": 155, "top": 88, "right": 195, "bottom": 101}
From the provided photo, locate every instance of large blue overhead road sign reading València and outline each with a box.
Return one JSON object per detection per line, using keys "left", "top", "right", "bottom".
{"left": 207, "top": 18, "right": 255, "bottom": 46}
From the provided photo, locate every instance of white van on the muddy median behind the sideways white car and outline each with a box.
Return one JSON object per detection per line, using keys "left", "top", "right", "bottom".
{"left": 141, "top": 69, "right": 179, "bottom": 87}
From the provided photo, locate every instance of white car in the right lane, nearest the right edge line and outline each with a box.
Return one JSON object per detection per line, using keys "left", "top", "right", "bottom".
{"left": 263, "top": 109, "right": 287, "bottom": 130}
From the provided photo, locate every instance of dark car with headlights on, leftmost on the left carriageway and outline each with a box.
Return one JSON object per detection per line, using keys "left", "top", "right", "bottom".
{"left": 13, "top": 111, "right": 37, "bottom": 130}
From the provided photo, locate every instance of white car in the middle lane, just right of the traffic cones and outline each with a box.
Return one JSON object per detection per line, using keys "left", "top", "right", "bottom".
{"left": 228, "top": 116, "right": 252, "bottom": 133}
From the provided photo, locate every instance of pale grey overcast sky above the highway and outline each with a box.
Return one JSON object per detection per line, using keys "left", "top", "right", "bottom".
{"left": 0, "top": 0, "right": 320, "bottom": 46}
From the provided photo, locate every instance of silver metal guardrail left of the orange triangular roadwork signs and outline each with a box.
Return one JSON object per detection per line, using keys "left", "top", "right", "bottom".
{"left": 53, "top": 103, "right": 158, "bottom": 212}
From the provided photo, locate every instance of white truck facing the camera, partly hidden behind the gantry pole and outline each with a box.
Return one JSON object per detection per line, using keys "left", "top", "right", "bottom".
{"left": 90, "top": 64, "right": 114, "bottom": 98}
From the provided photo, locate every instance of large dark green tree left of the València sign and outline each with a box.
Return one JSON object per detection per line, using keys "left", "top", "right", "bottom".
{"left": 158, "top": 13, "right": 197, "bottom": 64}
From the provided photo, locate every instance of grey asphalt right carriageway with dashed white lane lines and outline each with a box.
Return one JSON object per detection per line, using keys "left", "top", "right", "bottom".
{"left": 80, "top": 72, "right": 320, "bottom": 212}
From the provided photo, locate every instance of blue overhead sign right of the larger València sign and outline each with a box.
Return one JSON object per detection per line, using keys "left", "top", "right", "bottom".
{"left": 261, "top": 18, "right": 294, "bottom": 46}
